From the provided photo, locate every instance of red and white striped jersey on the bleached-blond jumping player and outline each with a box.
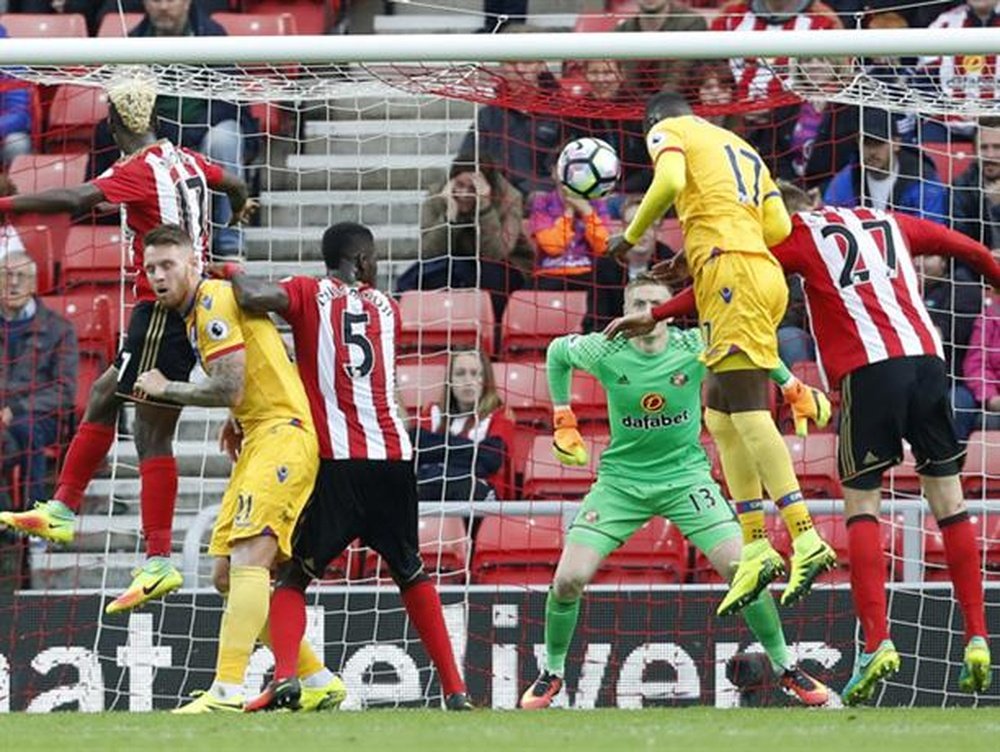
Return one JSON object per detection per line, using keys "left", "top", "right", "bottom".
{"left": 91, "top": 140, "right": 223, "bottom": 300}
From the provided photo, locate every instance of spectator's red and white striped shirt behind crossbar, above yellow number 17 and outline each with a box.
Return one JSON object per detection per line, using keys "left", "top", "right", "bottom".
{"left": 711, "top": 0, "right": 842, "bottom": 102}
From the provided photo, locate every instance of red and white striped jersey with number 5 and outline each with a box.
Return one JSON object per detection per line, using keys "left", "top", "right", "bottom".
{"left": 281, "top": 277, "right": 413, "bottom": 460}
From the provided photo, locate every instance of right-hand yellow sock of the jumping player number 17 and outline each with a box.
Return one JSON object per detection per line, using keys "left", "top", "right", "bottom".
{"left": 729, "top": 410, "right": 812, "bottom": 540}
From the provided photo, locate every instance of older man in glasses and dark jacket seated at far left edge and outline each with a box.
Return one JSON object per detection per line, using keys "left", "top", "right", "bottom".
{"left": 0, "top": 251, "right": 77, "bottom": 506}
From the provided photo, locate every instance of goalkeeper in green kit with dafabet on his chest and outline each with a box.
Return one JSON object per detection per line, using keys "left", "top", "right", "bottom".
{"left": 521, "top": 275, "right": 830, "bottom": 710}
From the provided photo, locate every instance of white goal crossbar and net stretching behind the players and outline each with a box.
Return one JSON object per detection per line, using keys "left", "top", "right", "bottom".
{"left": 0, "top": 9, "right": 1000, "bottom": 712}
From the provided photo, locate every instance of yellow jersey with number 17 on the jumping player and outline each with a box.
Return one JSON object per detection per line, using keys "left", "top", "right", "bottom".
{"left": 646, "top": 115, "right": 781, "bottom": 275}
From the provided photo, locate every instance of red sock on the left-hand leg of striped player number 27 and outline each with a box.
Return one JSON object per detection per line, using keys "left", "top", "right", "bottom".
{"left": 847, "top": 514, "right": 889, "bottom": 653}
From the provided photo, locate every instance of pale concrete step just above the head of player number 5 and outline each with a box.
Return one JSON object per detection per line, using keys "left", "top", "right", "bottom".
{"left": 260, "top": 190, "right": 428, "bottom": 228}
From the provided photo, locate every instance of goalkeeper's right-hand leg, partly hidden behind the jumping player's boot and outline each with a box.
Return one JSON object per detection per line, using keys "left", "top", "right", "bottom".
{"left": 691, "top": 533, "right": 830, "bottom": 706}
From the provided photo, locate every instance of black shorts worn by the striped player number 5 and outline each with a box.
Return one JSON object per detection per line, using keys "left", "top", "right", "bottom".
{"left": 292, "top": 459, "right": 424, "bottom": 584}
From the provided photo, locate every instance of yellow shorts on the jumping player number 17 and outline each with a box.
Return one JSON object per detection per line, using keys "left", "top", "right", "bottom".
{"left": 694, "top": 251, "right": 788, "bottom": 371}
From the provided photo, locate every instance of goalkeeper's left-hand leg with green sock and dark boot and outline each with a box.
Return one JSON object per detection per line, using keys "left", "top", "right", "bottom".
{"left": 521, "top": 541, "right": 600, "bottom": 710}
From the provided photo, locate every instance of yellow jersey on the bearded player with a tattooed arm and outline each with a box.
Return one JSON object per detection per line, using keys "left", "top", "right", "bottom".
{"left": 184, "top": 279, "right": 312, "bottom": 432}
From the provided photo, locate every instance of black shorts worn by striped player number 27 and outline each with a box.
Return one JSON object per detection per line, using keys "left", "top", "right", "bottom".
{"left": 837, "top": 355, "right": 965, "bottom": 491}
